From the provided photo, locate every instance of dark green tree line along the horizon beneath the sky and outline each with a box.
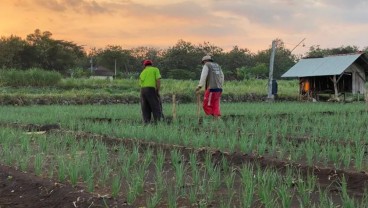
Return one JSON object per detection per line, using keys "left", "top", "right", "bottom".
{"left": 0, "top": 29, "right": 368, "bottom": 80}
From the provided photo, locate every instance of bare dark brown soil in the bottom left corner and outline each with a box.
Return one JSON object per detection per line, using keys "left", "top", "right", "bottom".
{"left": 0, "top": 165, "right": 129, "bottom": 208}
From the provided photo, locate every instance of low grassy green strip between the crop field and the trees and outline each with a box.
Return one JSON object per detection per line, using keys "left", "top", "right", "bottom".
{"left": 0, "top": 74, "right": 299, "bottom": 105}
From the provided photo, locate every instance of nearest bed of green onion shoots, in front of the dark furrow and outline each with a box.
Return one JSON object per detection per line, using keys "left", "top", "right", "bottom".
{"left": 0, "top": 128, "right": 368, "bottom": 207}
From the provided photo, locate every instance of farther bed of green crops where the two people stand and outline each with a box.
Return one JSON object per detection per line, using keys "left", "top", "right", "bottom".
{"left": 1, "top": 103, "right": 368, "bottom": 171}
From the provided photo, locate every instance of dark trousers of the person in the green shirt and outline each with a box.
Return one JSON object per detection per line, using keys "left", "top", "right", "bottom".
{"left": 141, "top": 87, "right": 162, "bottom": 123}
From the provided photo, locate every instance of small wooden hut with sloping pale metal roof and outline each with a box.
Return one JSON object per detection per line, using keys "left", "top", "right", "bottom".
{"left": 281, "top": 53, "right": 368, "bottom": 100}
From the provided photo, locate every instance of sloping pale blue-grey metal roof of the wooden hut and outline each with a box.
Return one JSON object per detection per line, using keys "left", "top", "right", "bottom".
{"left": 281, "top": 53, "right": 368, "bottom": 77}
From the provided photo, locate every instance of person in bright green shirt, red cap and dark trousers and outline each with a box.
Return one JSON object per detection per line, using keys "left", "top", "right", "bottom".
{"left": 139, "top": 60, "right": 163, "bottom": 124}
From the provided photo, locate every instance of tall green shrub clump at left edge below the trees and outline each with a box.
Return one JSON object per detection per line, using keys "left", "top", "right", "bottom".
{"left": 0, "top": 68, "right": 62, "bottom": 87}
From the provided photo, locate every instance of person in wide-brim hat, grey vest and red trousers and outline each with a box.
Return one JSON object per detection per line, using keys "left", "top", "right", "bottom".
{"left": 196, "top": 55, "right": 224, "bottom": 118}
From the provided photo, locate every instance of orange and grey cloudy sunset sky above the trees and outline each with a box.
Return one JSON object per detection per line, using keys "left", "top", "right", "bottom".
{"left": 0, "top": 0, "right": 368, "bottom": 54}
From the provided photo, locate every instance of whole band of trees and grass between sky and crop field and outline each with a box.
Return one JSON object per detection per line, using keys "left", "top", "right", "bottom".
{"left": 0, "top": 29, "right": 368, "bottom": 105}
